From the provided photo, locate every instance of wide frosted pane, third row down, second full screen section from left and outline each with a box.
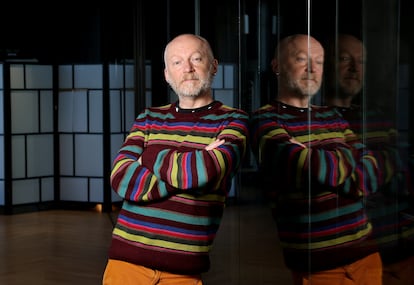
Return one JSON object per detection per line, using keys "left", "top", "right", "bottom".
{"left": 75, "top": 135, "right": 103, "bottom": 176}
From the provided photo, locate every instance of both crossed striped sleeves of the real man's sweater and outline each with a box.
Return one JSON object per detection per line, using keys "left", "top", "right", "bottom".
{"left": 111, "top": 107, "right": 248, "bottom": 202}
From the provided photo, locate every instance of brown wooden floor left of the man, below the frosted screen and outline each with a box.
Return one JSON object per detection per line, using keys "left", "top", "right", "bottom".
{"left": 0, "top": 206, "right": 112, "bottom": 285}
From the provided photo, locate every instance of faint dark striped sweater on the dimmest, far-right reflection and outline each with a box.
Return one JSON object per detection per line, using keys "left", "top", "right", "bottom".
{"left": 337, "top": 105, "right": 414, "bottom": 264}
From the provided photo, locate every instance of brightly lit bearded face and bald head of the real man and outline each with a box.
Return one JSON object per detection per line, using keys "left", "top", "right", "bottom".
{"left": 164, "top": 37, "right": 215, "bottom": 97}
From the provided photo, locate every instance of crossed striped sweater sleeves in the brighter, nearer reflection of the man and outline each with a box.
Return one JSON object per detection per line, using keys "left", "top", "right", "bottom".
{"left": 253, "top": 110, "right": 378, "bottom": 196}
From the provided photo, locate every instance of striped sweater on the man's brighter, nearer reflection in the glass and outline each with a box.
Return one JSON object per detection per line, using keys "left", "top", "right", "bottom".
{"left": 251, "top": 102, "right": 381, "bottom": 271}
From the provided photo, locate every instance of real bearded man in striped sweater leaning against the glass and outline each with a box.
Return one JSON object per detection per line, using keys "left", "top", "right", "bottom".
{"left": 103, "top": 34, "right": 248, "bottom": 285}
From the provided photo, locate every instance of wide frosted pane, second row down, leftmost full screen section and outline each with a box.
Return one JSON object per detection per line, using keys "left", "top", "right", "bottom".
{"left": 11, "top": 91, "right": 39, "bottom": 134}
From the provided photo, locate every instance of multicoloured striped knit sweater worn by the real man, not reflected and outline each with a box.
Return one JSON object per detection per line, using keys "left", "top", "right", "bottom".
{"left": 109, "top": 101, "right": 248, "bottom": 274}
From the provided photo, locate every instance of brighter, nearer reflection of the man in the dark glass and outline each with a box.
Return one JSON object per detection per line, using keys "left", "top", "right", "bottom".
{"left": 251, "top": 34, "right": 382, "bottom": 285}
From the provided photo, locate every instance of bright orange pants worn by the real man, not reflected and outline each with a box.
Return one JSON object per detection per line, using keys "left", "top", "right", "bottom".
{"left": 102, "top": 259, "right": 203, "bottom": 285}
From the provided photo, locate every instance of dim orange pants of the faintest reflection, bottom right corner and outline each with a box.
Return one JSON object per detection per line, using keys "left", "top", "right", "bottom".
{"left": 382, "top": 256, "right": 414, "bottom": 285}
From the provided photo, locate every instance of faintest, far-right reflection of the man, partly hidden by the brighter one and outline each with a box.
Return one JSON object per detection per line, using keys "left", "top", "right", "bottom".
{"left": 324, "top": 34, "right": 414, "bottom": 285}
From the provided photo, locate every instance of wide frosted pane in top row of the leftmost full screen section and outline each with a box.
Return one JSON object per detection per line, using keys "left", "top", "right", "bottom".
{"left": 26, "top": 64, "right": 53, "bottom": 89}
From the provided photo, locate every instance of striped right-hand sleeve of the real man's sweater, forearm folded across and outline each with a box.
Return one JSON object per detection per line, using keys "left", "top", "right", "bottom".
{"left": 142, "top": 112, "right": 248, "bottom": 194}
